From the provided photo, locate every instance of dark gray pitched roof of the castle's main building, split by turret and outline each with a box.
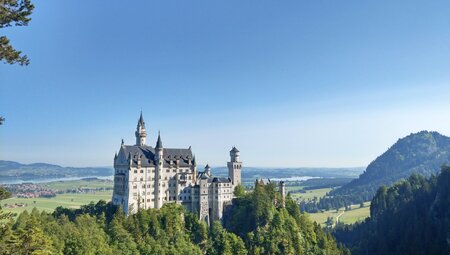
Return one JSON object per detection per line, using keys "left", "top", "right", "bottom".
{"left": 119, "top": 145, "right": 194, "bottom": 167}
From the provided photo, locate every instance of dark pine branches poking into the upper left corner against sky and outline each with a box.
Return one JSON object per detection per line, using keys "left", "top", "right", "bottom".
{"left": 0, "top": 0, "right": 34, "bottom": 65}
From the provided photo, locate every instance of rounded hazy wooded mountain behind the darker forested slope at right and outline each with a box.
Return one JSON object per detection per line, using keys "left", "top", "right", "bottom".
{"left": 330, "top": 131, "right": 450, "bottom": 203}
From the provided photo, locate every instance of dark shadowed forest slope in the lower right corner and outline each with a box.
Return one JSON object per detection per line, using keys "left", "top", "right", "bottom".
{"left": 334, "top": 167, "right": 450, "bottom": 255}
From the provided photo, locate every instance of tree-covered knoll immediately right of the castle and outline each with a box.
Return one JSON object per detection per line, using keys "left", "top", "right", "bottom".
{"left": 224, "top": 183, "right": 345, "bottom": 254}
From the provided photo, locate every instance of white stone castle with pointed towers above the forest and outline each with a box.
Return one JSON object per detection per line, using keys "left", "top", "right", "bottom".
{"left": 112, "top": 112, "right": 242, "bottom": 223}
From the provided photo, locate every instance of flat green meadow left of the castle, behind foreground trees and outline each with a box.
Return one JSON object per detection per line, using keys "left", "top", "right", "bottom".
{"left": 1, "top": 190, "right": 112, "bottom": 214}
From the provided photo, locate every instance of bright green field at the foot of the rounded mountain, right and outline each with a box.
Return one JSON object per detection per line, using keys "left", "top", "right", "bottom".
{"left": 309, "top": 202, "right": 370, "bottom": 226}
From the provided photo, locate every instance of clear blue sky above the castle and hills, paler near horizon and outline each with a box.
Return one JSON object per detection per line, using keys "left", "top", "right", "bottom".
{"left": 0, "top": 0, "right": 450, "bottom": 167}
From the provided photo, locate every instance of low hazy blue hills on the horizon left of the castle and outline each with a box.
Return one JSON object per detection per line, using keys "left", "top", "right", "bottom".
{"left": 0, "top": 160, "right": 113, "bottom": 183}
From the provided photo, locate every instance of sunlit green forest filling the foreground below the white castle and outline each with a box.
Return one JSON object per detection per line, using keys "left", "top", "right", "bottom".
{"left": 0, "top": 185, "right": 348, "bottom": 255}
